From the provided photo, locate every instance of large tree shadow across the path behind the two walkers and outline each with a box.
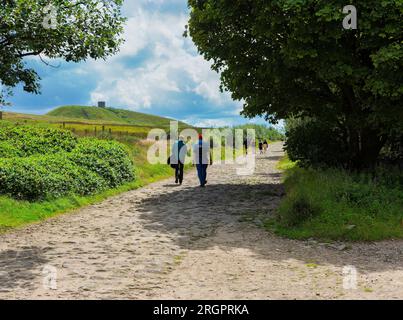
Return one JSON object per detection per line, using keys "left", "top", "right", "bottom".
{"left": 136, "top": 181, "right": 403, "bottom": 271}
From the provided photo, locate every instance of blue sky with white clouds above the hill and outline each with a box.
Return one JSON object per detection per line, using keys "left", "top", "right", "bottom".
{"left": 6, "top": 0, "right": 272, "bottom": 126}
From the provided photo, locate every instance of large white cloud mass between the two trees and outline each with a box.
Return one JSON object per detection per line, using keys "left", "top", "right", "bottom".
{"left": 87, "top": 0, "right": 239, "bottom": 113}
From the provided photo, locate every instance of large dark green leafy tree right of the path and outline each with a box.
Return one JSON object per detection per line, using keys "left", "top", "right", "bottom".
{"left": 188, "top": 0, "right": 403, "bottom": 169}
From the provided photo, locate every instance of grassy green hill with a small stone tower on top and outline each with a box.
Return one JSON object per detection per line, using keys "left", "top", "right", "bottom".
{"left": 47, "top": 106, "right": 188, "bottom": 127}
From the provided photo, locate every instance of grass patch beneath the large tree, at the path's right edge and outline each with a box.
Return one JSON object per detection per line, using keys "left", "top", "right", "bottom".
{"left": 266, "top": 162, "right": 403, "bottom": 241}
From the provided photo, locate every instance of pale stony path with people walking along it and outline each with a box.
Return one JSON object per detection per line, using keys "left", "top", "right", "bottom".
{"left": 0, "top": 144, "right": 403, "bottom": 299}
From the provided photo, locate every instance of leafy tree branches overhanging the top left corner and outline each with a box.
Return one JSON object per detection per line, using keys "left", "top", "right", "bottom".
{"left": 0, "top": 0, "right": 124, "bottom": 105}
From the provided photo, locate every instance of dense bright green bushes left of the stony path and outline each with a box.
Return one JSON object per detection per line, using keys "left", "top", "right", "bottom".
{"left": 0, "top": 126, "right": 134, "bottom": 201}
